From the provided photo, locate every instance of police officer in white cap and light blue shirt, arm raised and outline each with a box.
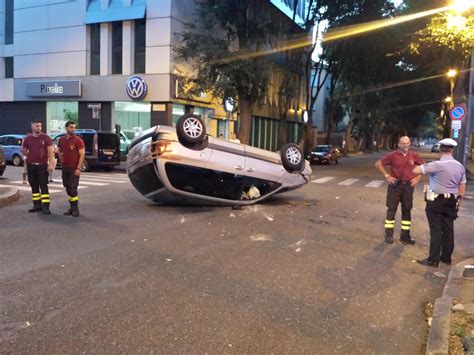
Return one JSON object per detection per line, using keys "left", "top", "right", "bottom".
{"left": 413, "top": 138, "right": 466, "bottom": 267}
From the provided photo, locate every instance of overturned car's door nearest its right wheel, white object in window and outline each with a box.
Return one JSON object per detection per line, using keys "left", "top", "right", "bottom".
{"left": 243, "top": 145, "right": 285, "bottom": 199}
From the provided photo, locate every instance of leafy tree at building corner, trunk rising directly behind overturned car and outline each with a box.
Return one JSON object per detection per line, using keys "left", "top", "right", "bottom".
{"left": 176, "top": 0, "right": 277, "bottom": 144}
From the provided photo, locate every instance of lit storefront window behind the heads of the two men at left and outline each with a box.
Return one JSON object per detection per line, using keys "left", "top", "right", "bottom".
{"left": 46, "top": 101, "right": 79, "bottom": 136}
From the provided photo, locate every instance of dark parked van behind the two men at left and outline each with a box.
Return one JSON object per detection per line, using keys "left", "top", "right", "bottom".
{"left": 53, "top": 129, "right": 120, "bottom": 171}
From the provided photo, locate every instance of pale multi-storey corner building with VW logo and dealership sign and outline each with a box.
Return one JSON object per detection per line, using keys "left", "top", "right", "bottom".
{"left": 0, "top": 0, "right": 308, "bottom": 149}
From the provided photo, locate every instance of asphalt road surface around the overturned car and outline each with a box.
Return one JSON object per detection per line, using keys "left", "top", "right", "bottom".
{"left": 0, "top": 149, "right": 474, "bottom": 354}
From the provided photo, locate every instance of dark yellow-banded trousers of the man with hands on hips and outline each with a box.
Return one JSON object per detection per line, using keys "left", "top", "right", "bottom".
{"left": 385, "top": 182, "right": 413, "bottom": 239}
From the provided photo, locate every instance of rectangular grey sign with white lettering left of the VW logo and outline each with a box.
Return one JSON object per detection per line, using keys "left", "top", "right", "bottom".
{"left": 26, "top": 80, "right": 81, "bottom": 97}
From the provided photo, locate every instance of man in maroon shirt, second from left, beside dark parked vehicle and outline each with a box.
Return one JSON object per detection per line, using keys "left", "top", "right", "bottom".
{"left": 58, "top": 121, "right": 86, "bottom": 217}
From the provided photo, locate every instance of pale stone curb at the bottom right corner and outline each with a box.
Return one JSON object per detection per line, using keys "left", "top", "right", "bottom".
{"left": 426, "top": 258, "right": 474, "bottom": 355}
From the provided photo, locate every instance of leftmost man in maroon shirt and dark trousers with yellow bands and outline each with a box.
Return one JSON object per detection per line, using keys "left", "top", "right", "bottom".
{"left": 23, "top": 120, "right": 54, "bottom": 215}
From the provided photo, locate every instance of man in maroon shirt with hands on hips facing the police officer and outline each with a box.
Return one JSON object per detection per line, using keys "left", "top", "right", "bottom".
{"left": 375, "top": 136, "right": 423, "bottom": 244}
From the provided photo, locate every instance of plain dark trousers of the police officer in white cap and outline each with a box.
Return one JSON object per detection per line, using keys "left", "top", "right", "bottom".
{"left": 425, "top": 197, "right": 457, "bottom": 262}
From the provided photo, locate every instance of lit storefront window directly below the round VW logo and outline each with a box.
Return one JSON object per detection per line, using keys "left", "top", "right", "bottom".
{"left": 114, "top": 101, "right": 151, "bottom": 139}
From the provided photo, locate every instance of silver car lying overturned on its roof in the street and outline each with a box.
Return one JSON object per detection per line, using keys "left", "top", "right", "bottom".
{"left": 127, "top": 114, "right": 311, "bottom": 205}
